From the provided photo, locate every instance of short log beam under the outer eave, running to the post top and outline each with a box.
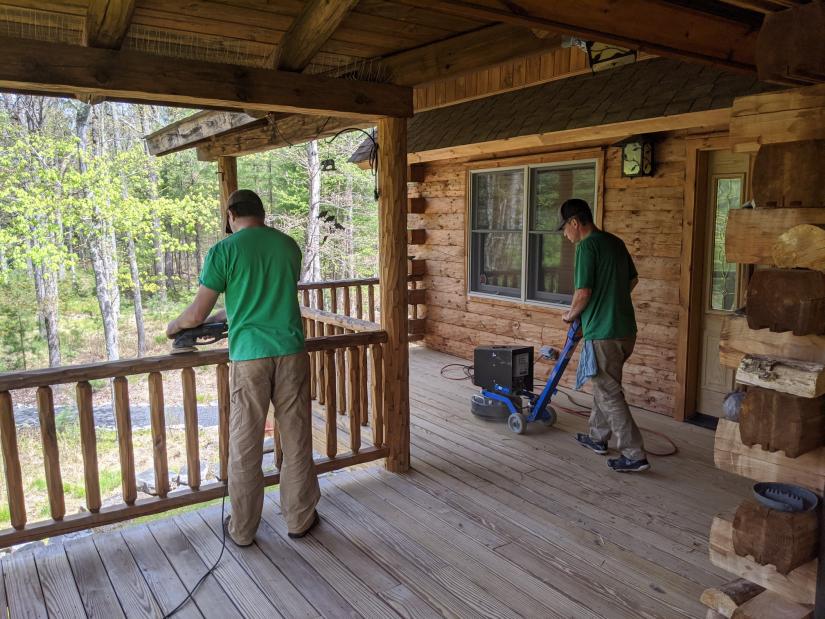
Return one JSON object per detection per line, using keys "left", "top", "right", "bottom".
{"left": 198, "top": 114, "right": 375, "bottom": 161}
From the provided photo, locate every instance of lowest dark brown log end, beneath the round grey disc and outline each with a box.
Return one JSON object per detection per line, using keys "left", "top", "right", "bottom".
{"left": 733, "top": 499, "right": 819, "bottom": 574}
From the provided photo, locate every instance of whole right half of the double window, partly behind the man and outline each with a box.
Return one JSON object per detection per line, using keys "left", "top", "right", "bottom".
{"left": 527, "top": 163, "right": 596, "bottom": 303}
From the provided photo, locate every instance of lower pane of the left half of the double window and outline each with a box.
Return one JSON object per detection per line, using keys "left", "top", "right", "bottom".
{"left": 471, "top": 232, "right": 522, "bottom": 297}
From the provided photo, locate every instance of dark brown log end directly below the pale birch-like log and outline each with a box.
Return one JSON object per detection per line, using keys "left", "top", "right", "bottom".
{"left": 739, "top": 387, "right": 825, "bottom": 458}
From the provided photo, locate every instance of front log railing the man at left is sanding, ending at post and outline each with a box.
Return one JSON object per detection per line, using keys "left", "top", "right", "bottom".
{"left": 0, "top": 330, "right": 387, "bottom": 547}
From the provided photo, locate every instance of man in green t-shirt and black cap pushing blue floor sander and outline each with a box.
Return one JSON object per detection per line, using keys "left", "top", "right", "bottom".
{"left": 559, "top": 198, "right": 650, "bottom": 472}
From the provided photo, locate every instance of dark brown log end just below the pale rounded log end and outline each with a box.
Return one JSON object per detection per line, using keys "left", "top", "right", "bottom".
{"left": 747, "top": 269, "right": 825, "bottom": 335}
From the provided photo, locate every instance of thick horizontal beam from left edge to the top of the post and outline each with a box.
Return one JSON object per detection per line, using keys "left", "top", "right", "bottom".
{"left": 0, "top": 37, "right": 413, "bottom": 120}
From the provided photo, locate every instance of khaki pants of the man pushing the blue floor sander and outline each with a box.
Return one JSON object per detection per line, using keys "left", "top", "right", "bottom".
{"left": 590, "top": 336, "right": 646, "bottom": 460}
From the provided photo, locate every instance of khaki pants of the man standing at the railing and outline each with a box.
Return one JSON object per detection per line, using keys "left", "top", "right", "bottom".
{"left": 229, "top": 352, "right": 321, "bottom": 544}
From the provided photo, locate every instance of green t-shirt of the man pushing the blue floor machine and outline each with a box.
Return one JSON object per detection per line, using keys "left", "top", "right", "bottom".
{"left": 574, "top": 230, "right": 639, "bottom": 340}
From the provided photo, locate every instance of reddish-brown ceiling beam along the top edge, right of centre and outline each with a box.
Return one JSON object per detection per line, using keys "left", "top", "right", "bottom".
{"left": 399, "top": 0, "right": 757, "bottom": 71}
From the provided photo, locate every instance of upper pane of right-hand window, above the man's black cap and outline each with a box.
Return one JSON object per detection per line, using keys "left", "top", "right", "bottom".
{"left": 530, "top": 163, "right": 596, "bottom": 232}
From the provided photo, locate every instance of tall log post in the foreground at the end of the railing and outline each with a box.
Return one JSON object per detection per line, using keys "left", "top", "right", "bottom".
{"left": 378, "top": 118, "right": 410, "bottom": 473}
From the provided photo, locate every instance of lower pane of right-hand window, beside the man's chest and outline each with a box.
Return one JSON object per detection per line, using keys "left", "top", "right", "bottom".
{"left": 528, "top": 233, "right": 575, "bottom": 303}
